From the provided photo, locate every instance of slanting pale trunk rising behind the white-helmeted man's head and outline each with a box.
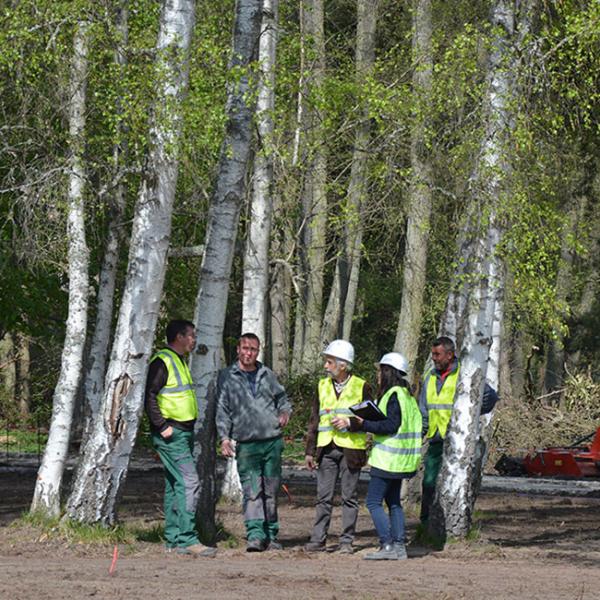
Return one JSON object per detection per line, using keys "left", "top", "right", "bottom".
{"left": 321, "top": 0, "right": 379, "bottom": 345}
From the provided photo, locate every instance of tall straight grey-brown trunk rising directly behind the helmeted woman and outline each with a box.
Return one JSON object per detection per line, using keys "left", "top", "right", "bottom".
{"left": 394, "top": 0, "right": 433, "bottom": 380}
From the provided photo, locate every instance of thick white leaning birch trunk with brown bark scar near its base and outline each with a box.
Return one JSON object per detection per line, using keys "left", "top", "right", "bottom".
{"left": 67, "top": 0, "right": 194, "bottom": 524}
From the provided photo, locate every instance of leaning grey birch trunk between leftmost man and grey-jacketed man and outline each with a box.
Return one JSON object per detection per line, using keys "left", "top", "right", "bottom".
{"left": 191, "top": 0, "right": 262, "bottom": 541}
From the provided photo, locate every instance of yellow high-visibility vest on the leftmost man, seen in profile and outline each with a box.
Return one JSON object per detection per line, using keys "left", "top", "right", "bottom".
{"left": 152, "top": 348, "right": 198, "bottom": 421}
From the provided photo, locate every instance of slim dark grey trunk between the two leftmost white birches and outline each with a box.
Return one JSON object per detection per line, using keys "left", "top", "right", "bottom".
{"left": 82, "top": 0, "right": 129, "bottom": 444}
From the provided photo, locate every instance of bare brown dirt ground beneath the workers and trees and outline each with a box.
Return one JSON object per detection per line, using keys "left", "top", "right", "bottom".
{"left": 0, "top": 470, "right": 600, "bottom": 600}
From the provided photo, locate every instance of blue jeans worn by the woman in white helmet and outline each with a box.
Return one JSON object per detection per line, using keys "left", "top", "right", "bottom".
{"left": 367, "top": 475, "right": 404, "bottom": 545}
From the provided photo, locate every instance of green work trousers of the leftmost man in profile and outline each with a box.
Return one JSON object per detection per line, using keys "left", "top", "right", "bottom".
{"left": 152, "top": 428, "right": 200, "bottom": 548}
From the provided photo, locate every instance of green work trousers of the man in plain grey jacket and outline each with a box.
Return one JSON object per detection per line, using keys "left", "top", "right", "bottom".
{"left": 236, "top": 437, "right": 283, "bottom": 540}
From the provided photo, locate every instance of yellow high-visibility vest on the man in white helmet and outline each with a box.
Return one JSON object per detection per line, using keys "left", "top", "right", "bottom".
{"left": 317, "top": 375, "right": 366, "bottom": 450}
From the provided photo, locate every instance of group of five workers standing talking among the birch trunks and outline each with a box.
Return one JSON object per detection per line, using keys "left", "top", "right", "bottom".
{"left": 145, "top": 320, "right": 498, "bottom": 560}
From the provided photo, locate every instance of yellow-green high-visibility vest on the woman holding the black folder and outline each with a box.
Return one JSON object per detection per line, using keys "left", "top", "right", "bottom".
{"left": 369, "top": 386, "right": 423, "bottom": 473}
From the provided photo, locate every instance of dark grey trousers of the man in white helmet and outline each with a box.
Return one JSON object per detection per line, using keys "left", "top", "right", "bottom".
{"left": 310, "top": 446, "right": 360, "bottom": 544}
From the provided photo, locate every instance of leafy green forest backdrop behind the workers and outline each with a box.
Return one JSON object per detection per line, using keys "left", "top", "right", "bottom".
{"left": 0, "top": 0, "right": 600, "bottom": 536}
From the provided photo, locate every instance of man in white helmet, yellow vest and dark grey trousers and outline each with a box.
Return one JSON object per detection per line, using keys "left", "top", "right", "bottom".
{"left": 304, "top": 340, "right": 371, "bottom": 554}
